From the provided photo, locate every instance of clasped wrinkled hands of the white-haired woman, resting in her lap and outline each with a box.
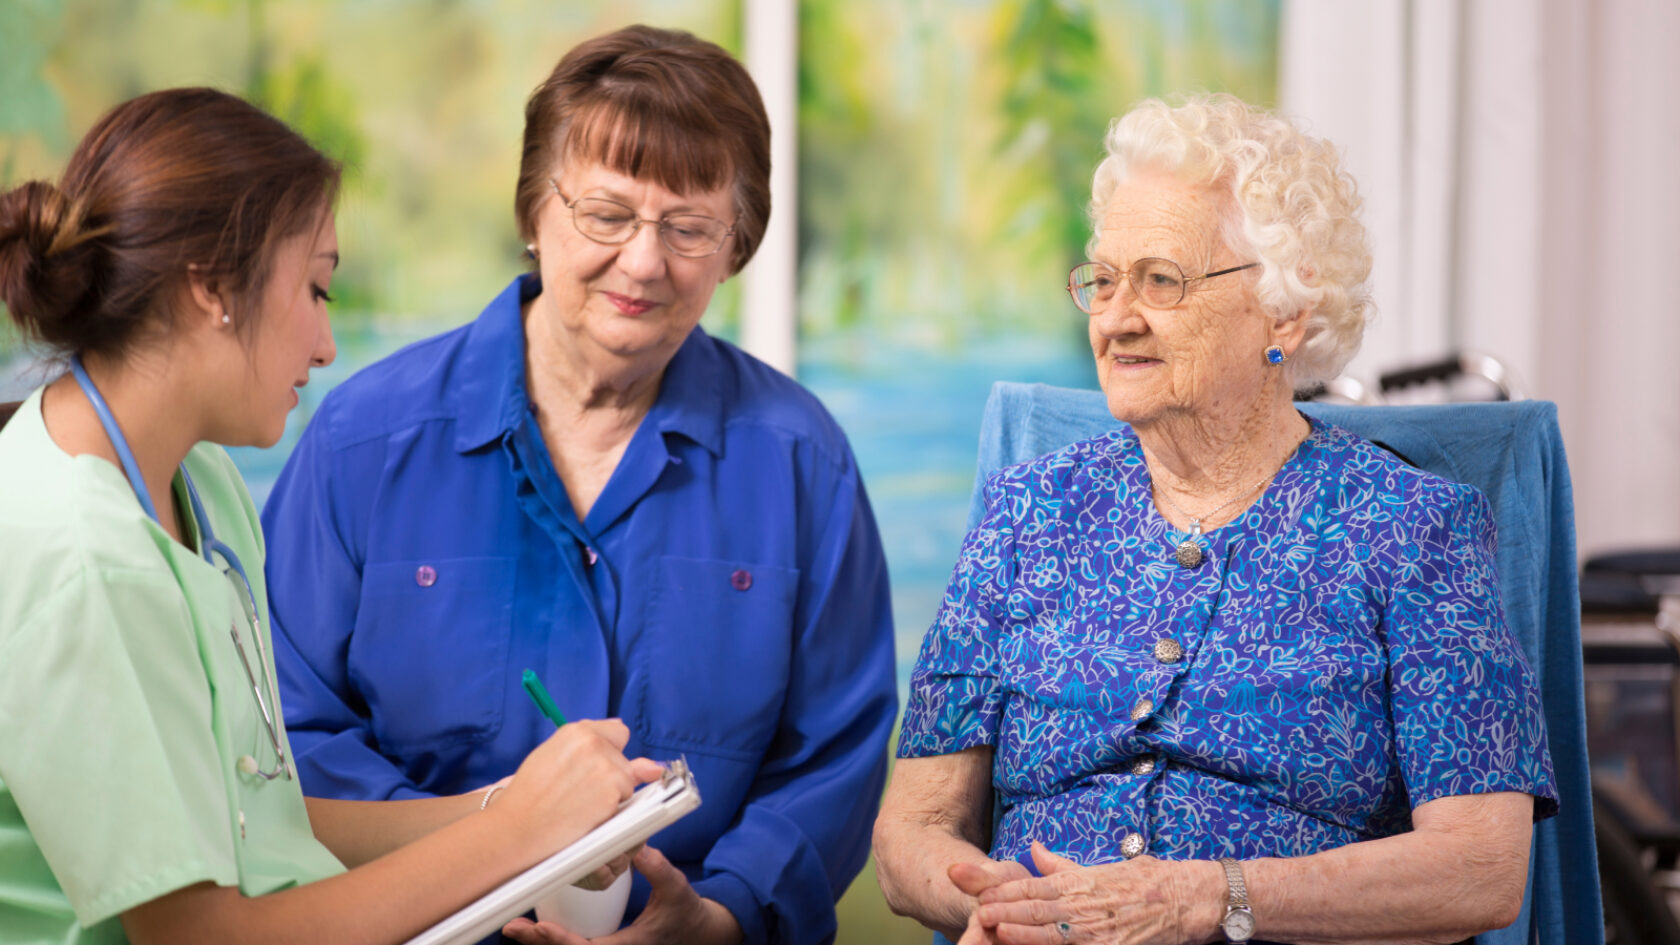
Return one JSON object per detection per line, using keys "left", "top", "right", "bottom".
{"left": 963, "top": 842, "right": 1218, "bottom": 945}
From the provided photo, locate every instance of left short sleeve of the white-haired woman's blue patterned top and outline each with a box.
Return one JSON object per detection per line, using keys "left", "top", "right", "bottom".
{"left": 899, "top": 473, "right": 1015, "bottom": 758}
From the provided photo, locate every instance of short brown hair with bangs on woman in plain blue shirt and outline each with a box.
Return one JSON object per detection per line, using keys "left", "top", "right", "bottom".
{"left": 514, "top": 25, "right": 769, "bottom": 272}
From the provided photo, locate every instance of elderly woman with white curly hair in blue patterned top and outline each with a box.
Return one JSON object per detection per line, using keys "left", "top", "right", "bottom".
{"left": 875, "top": 96, "right": 1556, "bottom": 945}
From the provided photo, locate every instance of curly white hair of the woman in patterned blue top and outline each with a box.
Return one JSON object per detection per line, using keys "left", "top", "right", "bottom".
{"left": 1090, "top": 94, "right": 1371, "bottom": 388}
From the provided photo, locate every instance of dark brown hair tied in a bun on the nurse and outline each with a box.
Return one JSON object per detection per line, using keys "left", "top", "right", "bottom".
{"left": 0, "top": 89, "right": 339, "bottom": 356}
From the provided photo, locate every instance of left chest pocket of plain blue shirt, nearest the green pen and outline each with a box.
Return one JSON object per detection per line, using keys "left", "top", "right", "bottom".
{"left": 349, "top": 558, "right": 514, "bottom": 755}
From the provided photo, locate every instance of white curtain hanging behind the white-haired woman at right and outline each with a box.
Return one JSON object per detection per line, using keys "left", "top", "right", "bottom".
{"left": 1280, "top": 0, "right": 1680, "bottom": 555}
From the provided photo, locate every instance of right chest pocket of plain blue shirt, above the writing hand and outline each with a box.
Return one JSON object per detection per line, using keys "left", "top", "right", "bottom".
{"left": 632, "top": 557, "right": 800, "bottom": 760}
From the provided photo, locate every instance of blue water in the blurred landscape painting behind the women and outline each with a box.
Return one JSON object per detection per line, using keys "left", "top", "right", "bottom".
{"left": 0, "top": 321, "right": 1095, "bottom": 698}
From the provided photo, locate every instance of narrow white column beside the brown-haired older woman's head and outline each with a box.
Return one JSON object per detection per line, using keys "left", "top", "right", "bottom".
{"left": 739, "top": 0, "right": 800, "bottom": 377}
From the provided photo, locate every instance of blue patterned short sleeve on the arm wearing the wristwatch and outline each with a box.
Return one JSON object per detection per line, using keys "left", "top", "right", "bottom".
{"left": 1384, "top": 486, "right": 1557, "bottom": 819}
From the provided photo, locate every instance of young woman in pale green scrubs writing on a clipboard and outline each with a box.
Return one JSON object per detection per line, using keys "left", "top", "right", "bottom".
{"left": 0, "top": 89, "right": 659, "bottom": 945}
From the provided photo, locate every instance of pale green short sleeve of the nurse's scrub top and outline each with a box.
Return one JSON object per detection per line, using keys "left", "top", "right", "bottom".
{"left": 0, "top": 570, "right": 239, "bottom": 927}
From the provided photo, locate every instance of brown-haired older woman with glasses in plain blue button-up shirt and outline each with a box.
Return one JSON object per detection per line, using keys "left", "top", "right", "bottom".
{"left": 264, "top": 27, "right": 895, "bottom": 943}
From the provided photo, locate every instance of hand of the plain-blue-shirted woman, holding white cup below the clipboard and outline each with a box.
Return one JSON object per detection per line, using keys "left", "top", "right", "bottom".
{"left": 502, "top": 846, "right": 741, "bottom": 945}
